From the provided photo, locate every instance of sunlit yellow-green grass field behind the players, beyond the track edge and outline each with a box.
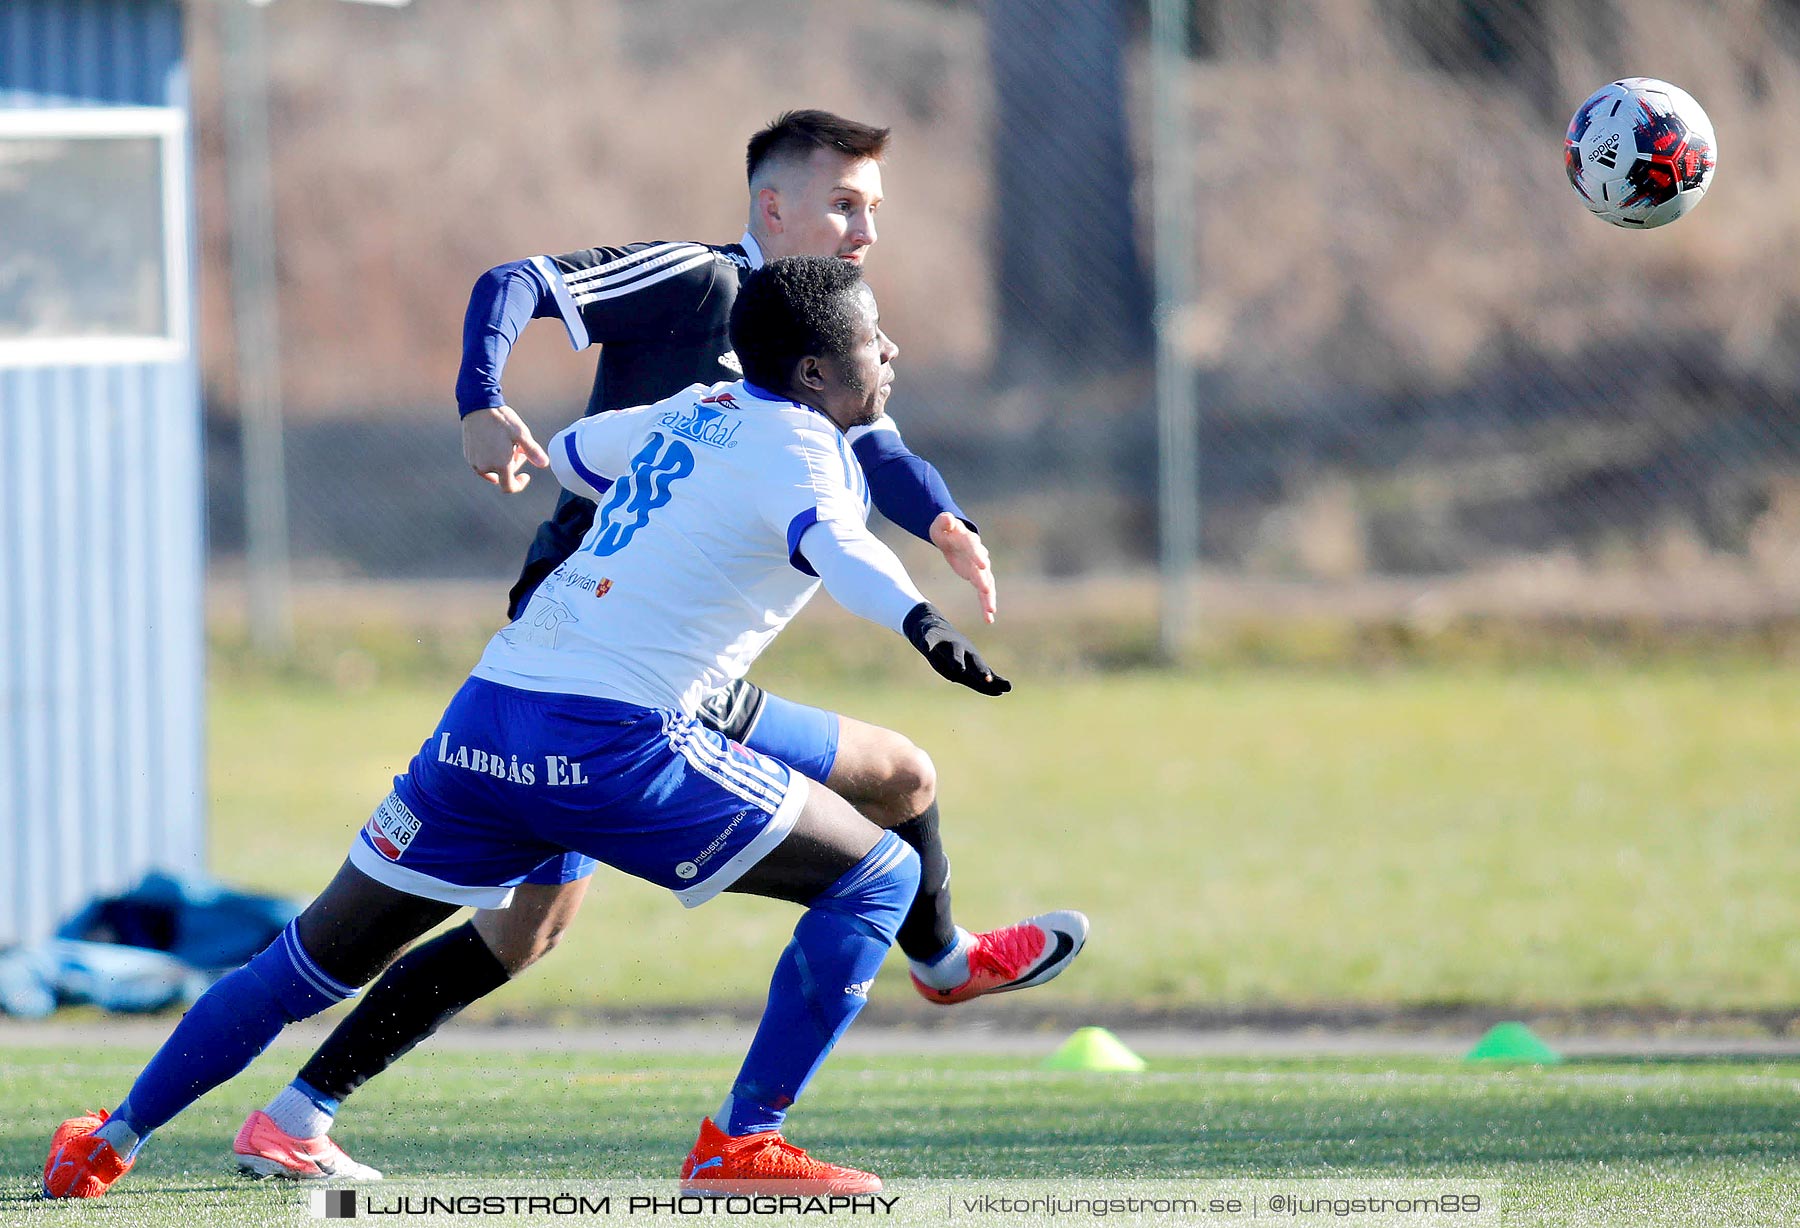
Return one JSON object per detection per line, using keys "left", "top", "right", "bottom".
{"left": 211, "top": 651, "right": 1800, "bottom": 1017}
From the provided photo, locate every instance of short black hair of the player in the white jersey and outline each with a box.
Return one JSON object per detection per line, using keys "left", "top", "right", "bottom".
{"left": 731, "top": 256, "right": 862, "bottom": 393}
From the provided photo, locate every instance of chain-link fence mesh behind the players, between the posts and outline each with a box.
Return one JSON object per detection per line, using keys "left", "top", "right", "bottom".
{"left": 200, "top": 0, "right": 1800, "bottom": 612}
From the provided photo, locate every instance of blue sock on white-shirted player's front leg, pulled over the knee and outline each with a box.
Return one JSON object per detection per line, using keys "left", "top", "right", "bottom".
{"left": 716, "top": 832, "right": 918, "bottom": 1134}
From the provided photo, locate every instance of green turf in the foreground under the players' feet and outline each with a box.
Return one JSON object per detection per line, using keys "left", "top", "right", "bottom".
{"left": 0, "top": 1048, "right": 1800, "bottom": 1228}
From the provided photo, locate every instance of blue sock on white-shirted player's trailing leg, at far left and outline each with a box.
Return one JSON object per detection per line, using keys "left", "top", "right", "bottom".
{"left": 113, "top": 922, "right": 356, "bottom": 1138}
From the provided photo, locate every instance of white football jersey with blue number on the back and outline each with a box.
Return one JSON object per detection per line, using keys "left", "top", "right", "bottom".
{"left": 473, "top": 382, "right": 869, "bottom": 713}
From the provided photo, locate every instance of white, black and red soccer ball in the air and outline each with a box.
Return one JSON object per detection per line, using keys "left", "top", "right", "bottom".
{"left": 1562, "top": 77, "right": 1719, "bottom": 230}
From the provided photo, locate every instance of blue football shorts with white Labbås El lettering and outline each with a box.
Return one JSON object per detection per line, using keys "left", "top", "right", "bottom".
{"left": 349, "top": 677, "right": 810, "bottom": 907}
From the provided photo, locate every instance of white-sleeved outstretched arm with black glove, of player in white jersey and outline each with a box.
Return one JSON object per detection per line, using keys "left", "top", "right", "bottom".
{"left": 794, "top": 520, "right": 1012, "bottom": 695}
